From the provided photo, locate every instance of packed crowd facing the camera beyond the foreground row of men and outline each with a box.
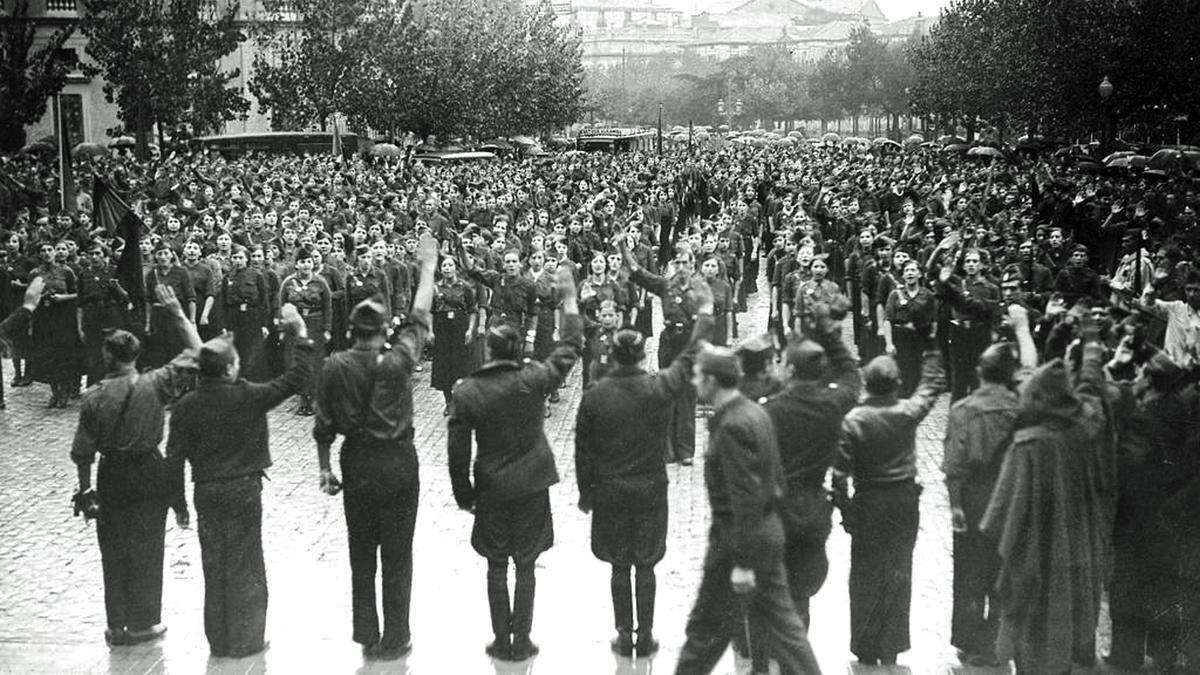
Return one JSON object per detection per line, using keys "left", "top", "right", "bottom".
{"left": 0, "top": 136, "right": 1200, "bottom": 671}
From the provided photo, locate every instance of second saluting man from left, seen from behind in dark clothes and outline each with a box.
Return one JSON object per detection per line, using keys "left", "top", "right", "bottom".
{"left": 167, "top": 303, "right": 313, "bottom": 658}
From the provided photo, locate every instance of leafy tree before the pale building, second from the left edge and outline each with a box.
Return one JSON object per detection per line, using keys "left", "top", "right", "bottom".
{"left": 80, "top": 0, "right": 250, "bottom": 156}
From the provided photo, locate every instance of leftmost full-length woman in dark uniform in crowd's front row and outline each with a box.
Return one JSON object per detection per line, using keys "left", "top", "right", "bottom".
{"left": 29, "top": 241, "right": 79, "bottom": 408}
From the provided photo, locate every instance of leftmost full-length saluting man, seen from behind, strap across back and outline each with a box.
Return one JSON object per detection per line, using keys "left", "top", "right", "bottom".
{"left": 68, "top": 279, "right": 200, "bottom": 645}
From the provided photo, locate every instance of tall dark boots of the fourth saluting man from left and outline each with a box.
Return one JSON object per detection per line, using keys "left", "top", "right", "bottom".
{"left": 485, "top": 560, "right": 539, "bottom": 661}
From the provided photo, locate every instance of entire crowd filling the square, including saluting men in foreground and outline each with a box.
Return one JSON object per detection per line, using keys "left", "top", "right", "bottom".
{"left": 0, "top": 135, "right": 1200, "bottom": 674}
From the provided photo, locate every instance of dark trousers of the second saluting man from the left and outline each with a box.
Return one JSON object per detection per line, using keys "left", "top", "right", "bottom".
{"left": 194, "top": 473, "right": 266, "bottom": 657}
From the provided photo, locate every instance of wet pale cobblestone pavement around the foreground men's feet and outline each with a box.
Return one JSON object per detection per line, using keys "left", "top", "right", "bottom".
{"left": 0, "top": 269, "right": 1132, "bottom": 675}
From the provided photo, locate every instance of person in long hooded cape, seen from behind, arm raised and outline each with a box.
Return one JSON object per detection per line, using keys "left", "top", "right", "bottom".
{"left": 980, "top": 331, "right": 1115, "bottom": 675}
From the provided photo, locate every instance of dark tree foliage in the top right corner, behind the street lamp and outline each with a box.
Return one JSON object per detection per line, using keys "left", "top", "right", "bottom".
{"left": 908, "top": 0, "right": 1200, "bottom": 140}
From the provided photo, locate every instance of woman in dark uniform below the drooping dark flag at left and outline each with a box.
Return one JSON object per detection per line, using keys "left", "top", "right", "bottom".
{"left": 76, "top": 241, "right": 130, "bottom": 387}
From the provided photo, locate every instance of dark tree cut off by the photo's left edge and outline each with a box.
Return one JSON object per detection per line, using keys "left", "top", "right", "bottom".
{"left": 0, "top": 0, "right": 74, "bottom": 153}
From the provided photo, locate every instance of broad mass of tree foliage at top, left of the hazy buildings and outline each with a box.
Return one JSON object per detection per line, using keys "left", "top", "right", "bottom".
{"left": 251, "top": 0, "right": 583, "bottom": 137}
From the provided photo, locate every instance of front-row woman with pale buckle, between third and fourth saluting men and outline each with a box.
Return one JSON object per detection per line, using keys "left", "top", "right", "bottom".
{"left": 430, "top": 256, "right": 479, "bottom": 416}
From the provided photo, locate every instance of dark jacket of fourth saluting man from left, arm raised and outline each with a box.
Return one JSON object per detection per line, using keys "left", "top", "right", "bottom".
{"left": 448, "top": 315, "right": 583, "bottom": 508}
